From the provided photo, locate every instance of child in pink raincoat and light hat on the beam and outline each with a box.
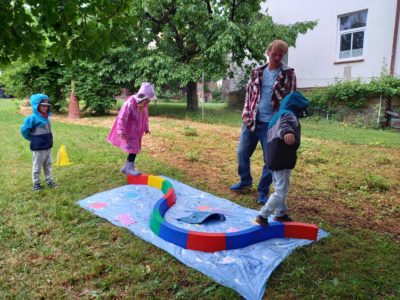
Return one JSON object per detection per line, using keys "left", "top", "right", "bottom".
{"left": 107, "top": 82, "right": 155, "bottom": 176}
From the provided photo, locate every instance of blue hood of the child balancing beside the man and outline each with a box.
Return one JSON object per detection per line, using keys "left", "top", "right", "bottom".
{"left": 268, "top": 92, "right": 310, "bottom": 128}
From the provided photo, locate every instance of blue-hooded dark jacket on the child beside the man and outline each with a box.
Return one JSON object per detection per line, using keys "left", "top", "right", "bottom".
{"left": 267, "top": 92, "right": 309, "bottom": 170}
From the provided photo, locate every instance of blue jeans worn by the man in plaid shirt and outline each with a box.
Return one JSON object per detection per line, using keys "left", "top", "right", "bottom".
{"left": 237, "top": 122, "right": 272, "bottom": 195}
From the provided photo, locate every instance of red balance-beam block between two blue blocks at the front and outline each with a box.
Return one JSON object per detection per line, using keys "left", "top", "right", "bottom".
{"left": 186, "top": 231, "right": 226, "bottom": 252}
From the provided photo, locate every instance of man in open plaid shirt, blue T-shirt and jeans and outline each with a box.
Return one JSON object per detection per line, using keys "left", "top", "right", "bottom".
{"left": 230, "top": 40, "right": 296, "bottom": 204}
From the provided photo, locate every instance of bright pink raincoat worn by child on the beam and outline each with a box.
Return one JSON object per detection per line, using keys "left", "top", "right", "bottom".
{"left": 107, "top": 95, "right": 149, "bottom": 154}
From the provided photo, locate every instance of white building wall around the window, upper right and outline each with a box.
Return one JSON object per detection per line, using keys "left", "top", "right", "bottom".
{"left": 261, "top": 0, "right": 400, "bottom": 87}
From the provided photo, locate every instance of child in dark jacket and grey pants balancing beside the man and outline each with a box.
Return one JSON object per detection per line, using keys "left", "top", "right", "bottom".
{"left": 256, "top": 92, "right": 309, "bottom": 226}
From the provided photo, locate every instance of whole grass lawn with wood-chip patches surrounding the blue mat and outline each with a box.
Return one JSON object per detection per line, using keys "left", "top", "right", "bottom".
{"left": 0, "top": 100, "right": 400, "bottom": 299}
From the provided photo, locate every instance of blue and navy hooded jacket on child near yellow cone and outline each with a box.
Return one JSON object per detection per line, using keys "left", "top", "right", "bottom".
{"left": 21, "top": 94, "right": 53, "bottom": 151}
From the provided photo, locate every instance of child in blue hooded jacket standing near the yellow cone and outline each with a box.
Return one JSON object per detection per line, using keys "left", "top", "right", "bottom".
{"left": 21, "top": 94, "right": 58, "bottom": 191}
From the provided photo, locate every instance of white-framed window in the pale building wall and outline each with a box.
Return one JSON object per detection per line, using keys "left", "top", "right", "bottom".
{"left": 338, "top": 10, "right": 367, "bottom": 60}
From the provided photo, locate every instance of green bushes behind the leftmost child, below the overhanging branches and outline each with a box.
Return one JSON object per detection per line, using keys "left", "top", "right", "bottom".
{"left": 0, "top": 59, "right": 120, "bottom": 114}
